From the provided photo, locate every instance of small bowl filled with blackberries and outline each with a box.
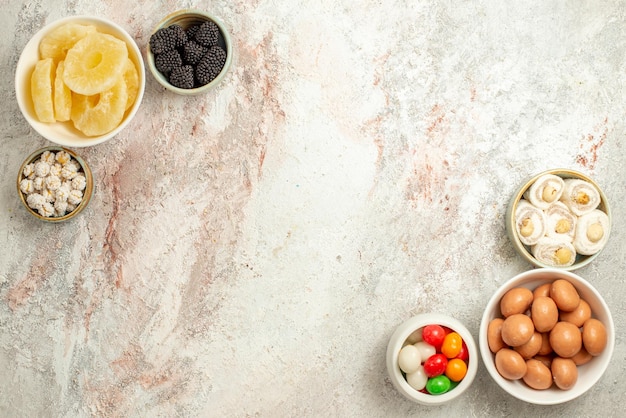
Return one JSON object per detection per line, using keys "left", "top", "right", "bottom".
{"left": 147, "top": 9, "right": 232, "bottom": 95}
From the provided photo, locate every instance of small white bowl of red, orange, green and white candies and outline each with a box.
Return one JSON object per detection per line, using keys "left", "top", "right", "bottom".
{"left": 386, "top": 313, "right": 478, "bottom": 405}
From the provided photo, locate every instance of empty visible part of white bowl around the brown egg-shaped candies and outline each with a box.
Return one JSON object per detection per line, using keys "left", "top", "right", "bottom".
{"left": 478, "top": 268, "right": 615, "bottom": 405}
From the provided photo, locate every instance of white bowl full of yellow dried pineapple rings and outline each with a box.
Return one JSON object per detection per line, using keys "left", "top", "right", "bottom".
{"left": 15, "top": 16, "right": 146, "bottom": 147}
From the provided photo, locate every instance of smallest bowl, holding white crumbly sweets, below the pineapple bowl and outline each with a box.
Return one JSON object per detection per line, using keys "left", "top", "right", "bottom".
{"left": 17, "top": 146, "right": 93, "bottom": 222}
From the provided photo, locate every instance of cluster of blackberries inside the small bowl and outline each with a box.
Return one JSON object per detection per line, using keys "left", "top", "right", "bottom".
{"left": 149, "top": 20, "right": 226, "bottom": 89}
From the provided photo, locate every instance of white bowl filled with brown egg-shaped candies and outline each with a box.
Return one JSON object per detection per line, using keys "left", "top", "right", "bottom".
{"left": 478, "top": 268, "right": 615, "bottom": 405}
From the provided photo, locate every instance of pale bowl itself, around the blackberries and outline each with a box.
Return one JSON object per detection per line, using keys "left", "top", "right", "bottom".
{"left": 146, "top": 9, "right": 233, "bottom": 96}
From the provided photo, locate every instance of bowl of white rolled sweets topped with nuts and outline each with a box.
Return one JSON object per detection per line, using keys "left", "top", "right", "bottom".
{"left": 506, "top": 169, "right": 611, "bottom": 270}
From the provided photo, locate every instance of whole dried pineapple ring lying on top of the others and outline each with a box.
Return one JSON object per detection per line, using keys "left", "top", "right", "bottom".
{"left": 63, "top": 32, "right": 128, "bottom": 96}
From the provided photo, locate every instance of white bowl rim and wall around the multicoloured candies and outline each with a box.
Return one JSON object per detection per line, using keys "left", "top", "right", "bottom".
{"left": 386, "top": 313, "right": 478, "bottom": 405}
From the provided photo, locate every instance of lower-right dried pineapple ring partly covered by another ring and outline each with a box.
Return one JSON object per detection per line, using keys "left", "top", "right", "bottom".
{"left": 72, "top": 76, "right": 128, "bottom": 136}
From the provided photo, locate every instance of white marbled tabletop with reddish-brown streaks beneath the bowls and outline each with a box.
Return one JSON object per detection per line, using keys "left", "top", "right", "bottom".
{"left": 0, "top": 0, "right": 626, "bottom": 417}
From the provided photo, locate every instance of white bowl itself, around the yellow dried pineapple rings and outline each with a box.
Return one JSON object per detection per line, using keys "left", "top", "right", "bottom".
{"left": 15, "top": 16, "right": 146, "bottom": 148}
